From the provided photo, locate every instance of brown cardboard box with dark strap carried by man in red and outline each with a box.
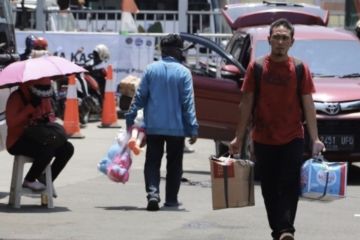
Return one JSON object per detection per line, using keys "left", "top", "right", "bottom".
{"left": 210, "top": 157, "right": 255, "bottom": 209}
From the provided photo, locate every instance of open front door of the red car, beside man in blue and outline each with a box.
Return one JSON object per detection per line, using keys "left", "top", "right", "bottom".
{"left": 180, "top": 33, "right": 245, "bottom": 140}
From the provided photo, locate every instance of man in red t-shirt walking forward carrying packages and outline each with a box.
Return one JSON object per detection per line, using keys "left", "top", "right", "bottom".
{"left": 229, "top": 19, "right": 325, "bottom": 240}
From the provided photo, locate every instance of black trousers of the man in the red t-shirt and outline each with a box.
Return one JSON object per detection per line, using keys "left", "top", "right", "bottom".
{"left": 254, "top": 138, "right": 304, "bottom": 239}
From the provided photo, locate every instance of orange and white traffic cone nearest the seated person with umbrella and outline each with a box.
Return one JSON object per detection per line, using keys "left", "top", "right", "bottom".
{"left": 64, "top": 75, "right": 85, "bottom": 138}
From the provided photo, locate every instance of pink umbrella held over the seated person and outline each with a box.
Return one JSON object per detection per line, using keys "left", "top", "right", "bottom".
{"left": 0, "top": 56, "right": 86, "bottom": 87}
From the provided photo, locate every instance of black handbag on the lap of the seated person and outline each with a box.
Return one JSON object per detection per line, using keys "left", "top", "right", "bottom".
{"left": 23, "top": 122, "right": 68, "bottom": 149}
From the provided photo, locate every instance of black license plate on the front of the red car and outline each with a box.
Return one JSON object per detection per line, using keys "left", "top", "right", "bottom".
{"left": 319, "top": 135, "right": 355, "bottom": 151}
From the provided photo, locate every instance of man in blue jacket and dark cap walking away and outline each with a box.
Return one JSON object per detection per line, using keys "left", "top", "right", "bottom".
{"left": 126, "top": 34, "right": 199, "bottom": 211}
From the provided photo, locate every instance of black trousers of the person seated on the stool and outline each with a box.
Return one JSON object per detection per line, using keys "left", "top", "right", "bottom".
{"left": 8, "top": 138, "right": 74, "bottom": 182}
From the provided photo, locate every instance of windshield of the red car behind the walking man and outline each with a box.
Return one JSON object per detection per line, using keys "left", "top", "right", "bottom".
{"left": 255, "top": 40, "right": 360, "bottom": 77}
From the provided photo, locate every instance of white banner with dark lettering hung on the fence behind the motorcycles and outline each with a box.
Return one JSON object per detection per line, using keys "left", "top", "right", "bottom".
{"left": 16, "top": 31, "right": 155, "bottom": 84}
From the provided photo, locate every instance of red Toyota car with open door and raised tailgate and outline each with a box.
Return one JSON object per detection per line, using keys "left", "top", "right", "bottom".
{"left": 181, "top": 2, "right": 360, "bottom": 162}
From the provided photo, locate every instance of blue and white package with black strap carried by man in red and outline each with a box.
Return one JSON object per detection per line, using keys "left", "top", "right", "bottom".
{"left": 301, "top": 159, "right": 347, "bottom": 201}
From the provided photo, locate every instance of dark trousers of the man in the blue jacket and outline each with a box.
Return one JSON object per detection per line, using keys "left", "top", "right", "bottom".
{"left": 144, "top": 135, "right": 185, "bottom": 203}
